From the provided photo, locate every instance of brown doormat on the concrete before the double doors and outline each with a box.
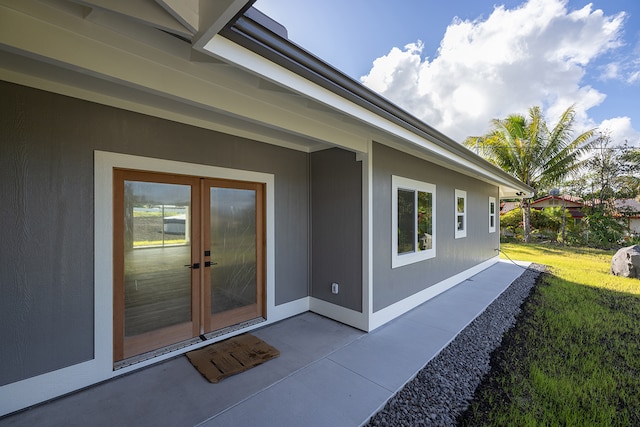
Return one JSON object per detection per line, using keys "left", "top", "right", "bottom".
{"left": 182, "top": 334, "right": 280, "bottom": 383}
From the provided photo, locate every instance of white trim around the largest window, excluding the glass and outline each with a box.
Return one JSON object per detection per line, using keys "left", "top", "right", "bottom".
{"left": 391, "top": 175, "right": 437, "bottom": 268}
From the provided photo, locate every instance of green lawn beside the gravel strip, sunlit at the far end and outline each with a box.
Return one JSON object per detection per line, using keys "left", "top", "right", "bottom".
{"left": 460, "top": 244, "right": 640, "bottom": 426}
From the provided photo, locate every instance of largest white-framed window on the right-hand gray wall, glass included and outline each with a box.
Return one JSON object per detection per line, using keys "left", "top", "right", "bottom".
{"left": 391, "top": 176, "right": 436, "bottom": 268}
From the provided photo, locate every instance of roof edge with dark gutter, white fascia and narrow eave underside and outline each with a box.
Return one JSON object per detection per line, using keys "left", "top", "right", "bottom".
{"left": 204, "top": 9, "right": 534, "bottom": 198}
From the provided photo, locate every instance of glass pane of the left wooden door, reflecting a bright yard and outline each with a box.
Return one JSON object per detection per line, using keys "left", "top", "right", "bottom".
{"left": 124, "top": 181, "right": 191, "bottom": 337}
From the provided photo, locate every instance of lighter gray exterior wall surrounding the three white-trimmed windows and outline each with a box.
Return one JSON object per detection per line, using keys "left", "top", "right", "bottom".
{"left": 373, "top": 143, "right": 500, "bottom": 311}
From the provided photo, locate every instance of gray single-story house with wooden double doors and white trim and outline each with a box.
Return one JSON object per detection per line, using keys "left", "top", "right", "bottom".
{"left": 0, "top": 0, "right": 532, "bottom": 414}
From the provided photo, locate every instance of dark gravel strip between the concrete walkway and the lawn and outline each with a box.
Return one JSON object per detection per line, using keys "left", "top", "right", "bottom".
{"left": 364, "top": 264, "right": 546, "bottom": 427}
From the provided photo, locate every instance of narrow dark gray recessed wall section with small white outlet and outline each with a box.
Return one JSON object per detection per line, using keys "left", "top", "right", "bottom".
{"left": 310, "top": 148, "right": 362, "bottom": 312}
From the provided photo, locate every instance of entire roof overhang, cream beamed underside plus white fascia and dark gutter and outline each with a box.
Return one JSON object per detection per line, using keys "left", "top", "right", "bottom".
{"left": 0, "top": 0, "right": 533, "bottom": 198}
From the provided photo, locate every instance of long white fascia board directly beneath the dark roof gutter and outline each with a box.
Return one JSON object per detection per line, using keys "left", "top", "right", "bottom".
{"left": 204, "top": 35, "right": 528, "bottom": 193}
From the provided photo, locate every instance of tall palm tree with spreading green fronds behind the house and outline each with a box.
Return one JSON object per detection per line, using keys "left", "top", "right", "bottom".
{"left": 463, "top": 106, "right": 597, "bottom": 242}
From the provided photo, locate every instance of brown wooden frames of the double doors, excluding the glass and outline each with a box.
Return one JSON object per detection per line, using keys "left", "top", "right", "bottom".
{"left": 113, "top": 168, "right": 267, "bottom": 361}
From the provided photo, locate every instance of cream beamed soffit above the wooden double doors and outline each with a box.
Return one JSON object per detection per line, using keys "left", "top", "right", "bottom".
{"left": 0, "top": 0, "right": 368, "bottom": 152}
